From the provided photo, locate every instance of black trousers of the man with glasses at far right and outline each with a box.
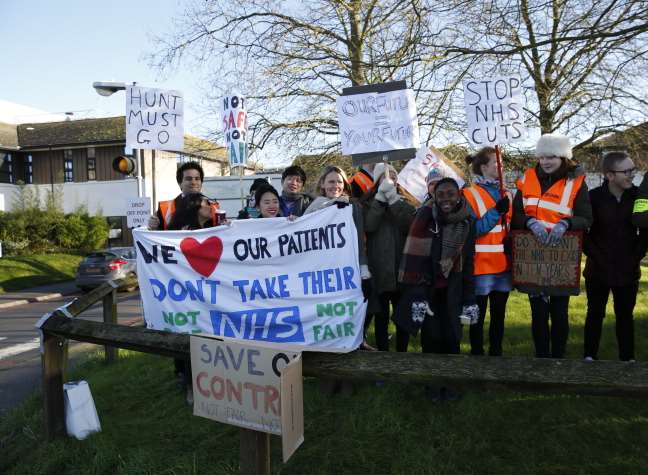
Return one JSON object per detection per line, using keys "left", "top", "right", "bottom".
{"left": 585, "top": 280, "right": 639, "bottom": 361}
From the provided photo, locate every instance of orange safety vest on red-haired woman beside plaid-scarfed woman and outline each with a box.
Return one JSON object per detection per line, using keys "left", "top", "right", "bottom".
{"left": 463, "top": 186, "right": 512, "bottom": 275}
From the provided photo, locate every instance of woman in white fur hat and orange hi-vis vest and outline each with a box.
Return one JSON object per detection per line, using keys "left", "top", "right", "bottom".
{"left": 511, "top": 134, "right": 592, "bottom": 358}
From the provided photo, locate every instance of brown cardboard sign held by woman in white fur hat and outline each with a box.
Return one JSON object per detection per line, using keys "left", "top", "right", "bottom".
{"left": 511, "top": 231, "right": 583, "bottom": 288}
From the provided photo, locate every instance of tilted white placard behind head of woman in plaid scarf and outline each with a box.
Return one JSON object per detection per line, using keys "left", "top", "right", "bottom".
{"left": 398, "top": 147, "right": 466, "bottom": 203}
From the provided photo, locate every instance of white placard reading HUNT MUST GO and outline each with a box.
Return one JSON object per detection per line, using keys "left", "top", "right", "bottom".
{"left": 126, "top": 85, "right": 184, "bottom": 152}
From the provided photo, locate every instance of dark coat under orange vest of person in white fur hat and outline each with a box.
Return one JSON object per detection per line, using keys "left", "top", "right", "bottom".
{"left": 511, "top": 165, "right": 593, "bottom": 296}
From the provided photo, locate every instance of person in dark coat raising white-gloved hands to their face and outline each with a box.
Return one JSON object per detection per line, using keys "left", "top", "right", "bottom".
{"left": 361, "top": 163, "right": 416, "bottom": 351}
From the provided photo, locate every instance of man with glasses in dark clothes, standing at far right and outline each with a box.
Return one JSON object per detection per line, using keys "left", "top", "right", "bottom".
{"left": 583, "top": 152, "right": 646, "bottom": 361}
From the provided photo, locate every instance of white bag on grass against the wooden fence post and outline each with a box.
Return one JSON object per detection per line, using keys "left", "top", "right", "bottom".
{"left": 63, "top": 381, "right": 101, "bottom": 440}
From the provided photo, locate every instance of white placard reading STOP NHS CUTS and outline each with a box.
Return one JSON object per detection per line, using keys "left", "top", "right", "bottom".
{"left": 463, "top": 76, "right": 526, "bottom": 146}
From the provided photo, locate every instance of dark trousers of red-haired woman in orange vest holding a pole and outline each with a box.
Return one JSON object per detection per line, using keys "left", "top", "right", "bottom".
{"left": 470, "top": 290, "right": 509, "bottom": 356}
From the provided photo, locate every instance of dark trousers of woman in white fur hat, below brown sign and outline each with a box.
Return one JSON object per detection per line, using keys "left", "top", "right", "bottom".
{"left": 529, "top": 296, "right": 569, "bottom": 358}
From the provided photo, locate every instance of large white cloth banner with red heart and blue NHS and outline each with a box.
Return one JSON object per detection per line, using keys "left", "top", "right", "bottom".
{"left": 133, "top": 207, "right": 367, "bottom": 352}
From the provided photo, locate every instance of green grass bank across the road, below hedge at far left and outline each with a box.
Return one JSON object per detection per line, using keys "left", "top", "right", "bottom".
{"left": 0, "top": 254, "right": 82, "bottom": 293}
